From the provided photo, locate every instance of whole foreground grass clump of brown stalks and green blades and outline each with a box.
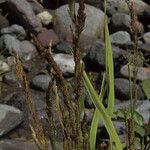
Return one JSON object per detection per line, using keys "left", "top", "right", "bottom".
{"left": 15, "top": 0, "right": 150, "bottom": 150}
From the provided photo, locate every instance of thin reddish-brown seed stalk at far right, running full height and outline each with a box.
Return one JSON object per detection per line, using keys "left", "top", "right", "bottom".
{"left": 126, "top": 0, "right": 138, "bottom": 150}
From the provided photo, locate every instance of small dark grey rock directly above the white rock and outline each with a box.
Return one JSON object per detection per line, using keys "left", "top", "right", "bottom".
{"left": 53, "top": 41, "right": 72, "bottom": 54}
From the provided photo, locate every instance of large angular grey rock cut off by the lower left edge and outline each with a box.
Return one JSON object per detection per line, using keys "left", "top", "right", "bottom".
{"left": 0, "top": 104, "right": 23, "bottom": 136}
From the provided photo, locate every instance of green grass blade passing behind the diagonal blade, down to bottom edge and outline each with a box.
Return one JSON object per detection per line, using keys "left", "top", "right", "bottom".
{"left": 89, "top": 74, "right": 105, "bottom": 150}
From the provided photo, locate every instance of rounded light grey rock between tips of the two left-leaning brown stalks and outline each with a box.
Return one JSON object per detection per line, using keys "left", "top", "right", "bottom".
{"left": 18, "top": 41, "right": 37, "bottom": 61}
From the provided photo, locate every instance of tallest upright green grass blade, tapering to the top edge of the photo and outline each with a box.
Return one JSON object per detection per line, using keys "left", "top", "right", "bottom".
{"left": 104, "top": 0, "right": 115, "bottom": 117}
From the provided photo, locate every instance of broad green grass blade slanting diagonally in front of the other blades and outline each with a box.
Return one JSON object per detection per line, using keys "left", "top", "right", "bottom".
{"left": 83, "top": 71, "right": 123, "bottom": 150}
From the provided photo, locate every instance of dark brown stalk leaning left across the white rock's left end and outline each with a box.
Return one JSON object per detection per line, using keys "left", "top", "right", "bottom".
{"left": 32, "top": 35, "right": 76, "bottom": 150}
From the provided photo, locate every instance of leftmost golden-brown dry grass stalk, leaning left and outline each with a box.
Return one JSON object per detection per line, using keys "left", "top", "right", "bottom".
{"left": 14, "top": 50, "right": 48, "bottom": 150}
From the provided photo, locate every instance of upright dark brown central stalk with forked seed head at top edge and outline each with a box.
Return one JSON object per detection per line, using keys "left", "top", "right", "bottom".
{"left": 69, "top": 0, "right": 86, "bottom": 150}
